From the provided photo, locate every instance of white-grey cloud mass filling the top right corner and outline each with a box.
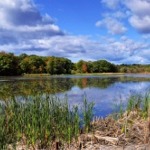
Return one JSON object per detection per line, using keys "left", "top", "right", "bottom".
{"left": 101, "top": 0, "right": 150, "bottom": 34}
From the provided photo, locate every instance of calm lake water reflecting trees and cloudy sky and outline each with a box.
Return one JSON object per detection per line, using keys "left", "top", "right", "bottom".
{"left": 0, "top": 74, "right": 150, "bottom": 116}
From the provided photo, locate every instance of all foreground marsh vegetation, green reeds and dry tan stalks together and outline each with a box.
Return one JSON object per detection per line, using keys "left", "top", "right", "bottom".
{"left": 0, "top": 93, "right": 150, "bottom": 149}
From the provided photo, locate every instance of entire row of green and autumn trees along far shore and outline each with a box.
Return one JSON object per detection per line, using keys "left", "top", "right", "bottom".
{"left": 0, "top": 52, "right": 150, "bottom": 76}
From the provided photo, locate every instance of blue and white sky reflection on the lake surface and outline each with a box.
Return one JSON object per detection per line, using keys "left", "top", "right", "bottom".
{"left": 67, "top": 82, "right": 150, "bottom": 116}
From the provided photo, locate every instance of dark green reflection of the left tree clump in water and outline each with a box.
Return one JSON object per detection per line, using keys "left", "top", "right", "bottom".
{"left": 0, "top": 78, "right": 74, "bottom": 99}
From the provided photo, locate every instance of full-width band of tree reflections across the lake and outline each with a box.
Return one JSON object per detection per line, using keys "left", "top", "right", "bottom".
{"left": 0, "top": 76, "right": 150, "bottom": 100}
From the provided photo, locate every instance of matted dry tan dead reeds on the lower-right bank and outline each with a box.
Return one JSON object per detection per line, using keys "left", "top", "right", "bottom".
{"left": 67, "top": 111, "right": 150, "bottom": 149}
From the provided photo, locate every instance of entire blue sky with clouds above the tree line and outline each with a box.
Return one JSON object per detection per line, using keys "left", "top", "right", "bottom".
{"left": 0, "top": 0, "right": 150, "bottom": 64}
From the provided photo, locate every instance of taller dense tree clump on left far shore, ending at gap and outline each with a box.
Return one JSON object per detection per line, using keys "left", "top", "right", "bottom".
{"left": 0, "top": 52, "right": 73, "bottom": 76}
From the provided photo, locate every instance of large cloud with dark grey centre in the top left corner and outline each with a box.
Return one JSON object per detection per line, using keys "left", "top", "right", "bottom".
{"left": 0, "top": 0, "right": 64, "bottom": 45}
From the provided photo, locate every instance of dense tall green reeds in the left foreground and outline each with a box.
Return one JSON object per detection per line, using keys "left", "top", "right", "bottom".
{"left": 0, "top": 94, "right": 93, "bottom": 149}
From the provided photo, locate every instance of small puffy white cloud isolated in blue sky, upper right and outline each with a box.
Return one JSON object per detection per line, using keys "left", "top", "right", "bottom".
{"left": 96, "top": 17, "right": 127, "bottom": 34}
